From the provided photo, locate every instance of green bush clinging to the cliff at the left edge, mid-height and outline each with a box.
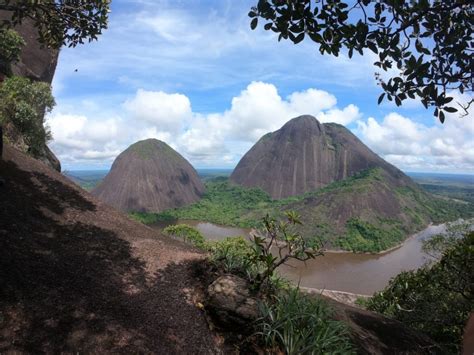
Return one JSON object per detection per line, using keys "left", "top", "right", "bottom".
{"left": 0, "top": 77, "right": 55, "bottom": 156}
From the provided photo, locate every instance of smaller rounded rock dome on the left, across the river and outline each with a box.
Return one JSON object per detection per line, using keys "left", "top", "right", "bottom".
{"left": 92, "top": 139, "right": 204, "bottom": 212}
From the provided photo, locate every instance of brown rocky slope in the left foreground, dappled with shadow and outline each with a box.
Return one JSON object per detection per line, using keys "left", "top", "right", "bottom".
{"left": 0, "top": 147, "right": 223, "bottom": 354}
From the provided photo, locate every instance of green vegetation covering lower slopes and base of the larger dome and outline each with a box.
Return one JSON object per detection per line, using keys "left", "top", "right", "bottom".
{"left": 132, "top": 168, "right": 474, "bottom": 252}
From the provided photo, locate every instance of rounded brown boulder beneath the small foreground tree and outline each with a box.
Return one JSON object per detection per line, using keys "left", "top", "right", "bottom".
{"left": 207, "top": 275, "right": 259, "bottom": 328}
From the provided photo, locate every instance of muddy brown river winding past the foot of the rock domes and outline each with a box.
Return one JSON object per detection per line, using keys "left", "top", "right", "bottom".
{"left": 155, "top": 220, "right": 445, "bottom": 295}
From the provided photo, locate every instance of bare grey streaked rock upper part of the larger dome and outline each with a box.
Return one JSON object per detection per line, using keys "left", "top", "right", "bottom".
{"left": 230, "top": 115, "right": 410, "bottom": 199}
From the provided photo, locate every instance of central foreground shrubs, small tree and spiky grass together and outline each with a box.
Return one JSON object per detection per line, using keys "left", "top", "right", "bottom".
{"left": 170, "top": 213, "right": 354, "bottom": 354}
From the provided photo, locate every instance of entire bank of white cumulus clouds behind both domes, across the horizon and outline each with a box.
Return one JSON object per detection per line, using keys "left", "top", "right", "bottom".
{"left": 47, "top": 82, "right": 474, "bottom": 171}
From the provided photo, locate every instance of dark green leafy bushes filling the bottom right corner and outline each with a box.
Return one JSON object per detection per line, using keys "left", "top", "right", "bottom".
{"left": 368, "top": 232, "right": 474, "bottom": 353}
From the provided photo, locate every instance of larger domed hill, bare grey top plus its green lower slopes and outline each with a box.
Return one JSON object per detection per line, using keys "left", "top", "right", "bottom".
{"left": 159, "top": 116, "right": 474, "bottom": 252}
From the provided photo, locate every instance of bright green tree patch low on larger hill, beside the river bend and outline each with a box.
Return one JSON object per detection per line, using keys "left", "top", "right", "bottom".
{"left": 336, "top": 218, "right": 406, "bottom": 253}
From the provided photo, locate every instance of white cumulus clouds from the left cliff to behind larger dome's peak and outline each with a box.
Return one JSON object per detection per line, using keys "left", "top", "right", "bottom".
{"left": 47, "top": 82, "right": 360, "bottom": 166}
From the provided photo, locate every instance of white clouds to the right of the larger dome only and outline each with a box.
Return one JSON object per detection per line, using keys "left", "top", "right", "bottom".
{"left": 355, "top": 94, "right": 474, "bottom": 172}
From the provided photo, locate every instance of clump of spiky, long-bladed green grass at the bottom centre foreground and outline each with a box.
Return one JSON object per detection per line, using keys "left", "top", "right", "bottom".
{"left": 256, "top": 288, "right": 355, "bottom": 355}
